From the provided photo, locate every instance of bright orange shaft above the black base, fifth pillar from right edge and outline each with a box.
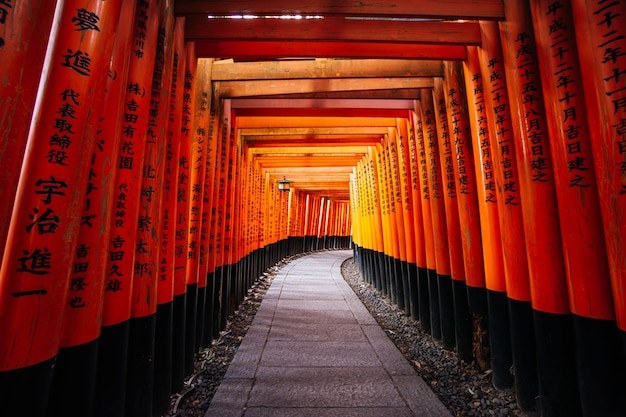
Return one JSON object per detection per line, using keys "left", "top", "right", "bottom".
{"left": 463, "top": 47, "right": 506, "bottom": 292}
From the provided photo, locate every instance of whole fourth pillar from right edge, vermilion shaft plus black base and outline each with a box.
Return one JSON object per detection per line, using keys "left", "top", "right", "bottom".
{"left": 478, "top": 21, "right": 537, "bottom": 404}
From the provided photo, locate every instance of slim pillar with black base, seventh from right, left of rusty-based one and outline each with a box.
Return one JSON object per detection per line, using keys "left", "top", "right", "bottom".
{"left": 433, "top": 78, "right": 472, "bottom": 361}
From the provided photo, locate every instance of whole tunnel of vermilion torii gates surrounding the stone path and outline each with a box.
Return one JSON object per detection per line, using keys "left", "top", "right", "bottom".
{"left": 0, "top": 0, "right": 626, "bottom": 417}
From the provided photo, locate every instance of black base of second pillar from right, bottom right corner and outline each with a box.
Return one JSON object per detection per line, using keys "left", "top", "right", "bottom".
{"left": 573, "top": 315, "right": 626, "bottom": 417}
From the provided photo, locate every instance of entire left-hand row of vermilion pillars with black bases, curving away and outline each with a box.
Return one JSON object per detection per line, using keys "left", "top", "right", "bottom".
{"left": 0, "top": 0, "right": 350, "bottom": 417}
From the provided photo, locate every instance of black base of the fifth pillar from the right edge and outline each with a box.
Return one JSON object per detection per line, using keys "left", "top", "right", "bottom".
{"left": 487, "top": 290, "right": 515, "bottom": 391}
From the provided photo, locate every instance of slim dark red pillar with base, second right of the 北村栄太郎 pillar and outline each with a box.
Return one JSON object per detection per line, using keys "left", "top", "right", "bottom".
{"left": 172, "top": 42, "right": 197, "bottom": 392}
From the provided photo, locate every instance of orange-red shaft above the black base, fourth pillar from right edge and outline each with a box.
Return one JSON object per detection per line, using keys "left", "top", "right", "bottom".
{"left": 478, "top": 22, "right": 531, "bottom": 301}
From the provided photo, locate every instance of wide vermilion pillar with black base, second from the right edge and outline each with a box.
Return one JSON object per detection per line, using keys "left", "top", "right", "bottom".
{"left": 531, "top": 0, "right": 624, "bottom": 415}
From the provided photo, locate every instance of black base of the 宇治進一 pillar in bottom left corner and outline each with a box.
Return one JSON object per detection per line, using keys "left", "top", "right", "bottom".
{"left": 0, "top": 357, "right": 56, "bottom": 417}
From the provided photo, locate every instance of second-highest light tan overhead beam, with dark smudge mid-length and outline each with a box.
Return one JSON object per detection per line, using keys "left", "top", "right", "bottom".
{"left": 216, "top": 77, "right": 434, "bottom": 98}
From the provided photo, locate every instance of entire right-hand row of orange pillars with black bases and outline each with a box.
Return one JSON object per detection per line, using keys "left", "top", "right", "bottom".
{"left": 351, "top": 1, "right": 626, "bottom": 416}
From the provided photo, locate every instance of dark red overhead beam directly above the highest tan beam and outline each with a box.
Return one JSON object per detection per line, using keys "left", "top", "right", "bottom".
{"left": 196, "top": 41, "right": 467, "bottom": 61}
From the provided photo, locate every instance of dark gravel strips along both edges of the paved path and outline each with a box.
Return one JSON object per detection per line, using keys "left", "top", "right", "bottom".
{"left": 164, "top": 253, "right": 526, "bottom": 417}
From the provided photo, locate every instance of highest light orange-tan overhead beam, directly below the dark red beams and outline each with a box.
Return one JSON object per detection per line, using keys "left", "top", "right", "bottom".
{"left": 211, "top": 58, "right": 443, "bottom": 81}
